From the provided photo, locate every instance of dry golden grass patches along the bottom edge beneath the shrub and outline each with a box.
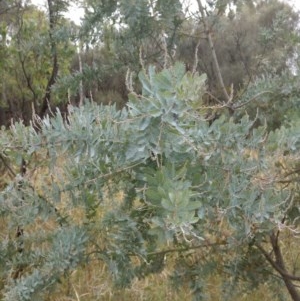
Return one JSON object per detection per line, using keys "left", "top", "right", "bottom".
{"left": 47, "top": 256, "right": 288, "bottom": 301}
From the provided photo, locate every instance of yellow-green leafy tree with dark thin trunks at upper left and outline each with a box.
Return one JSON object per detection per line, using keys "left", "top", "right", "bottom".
{"left": 1, "top": 3, "right": 75, "bottom": 124}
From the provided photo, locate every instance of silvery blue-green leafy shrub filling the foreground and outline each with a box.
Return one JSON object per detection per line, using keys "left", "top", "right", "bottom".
{"left": 0, "top": 63, "right": 300, "bottom": 300}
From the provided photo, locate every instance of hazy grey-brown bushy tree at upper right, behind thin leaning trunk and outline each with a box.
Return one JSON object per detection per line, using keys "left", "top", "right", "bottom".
{"left": 177, "top": 1, "right": 299, "bottom": 95}
